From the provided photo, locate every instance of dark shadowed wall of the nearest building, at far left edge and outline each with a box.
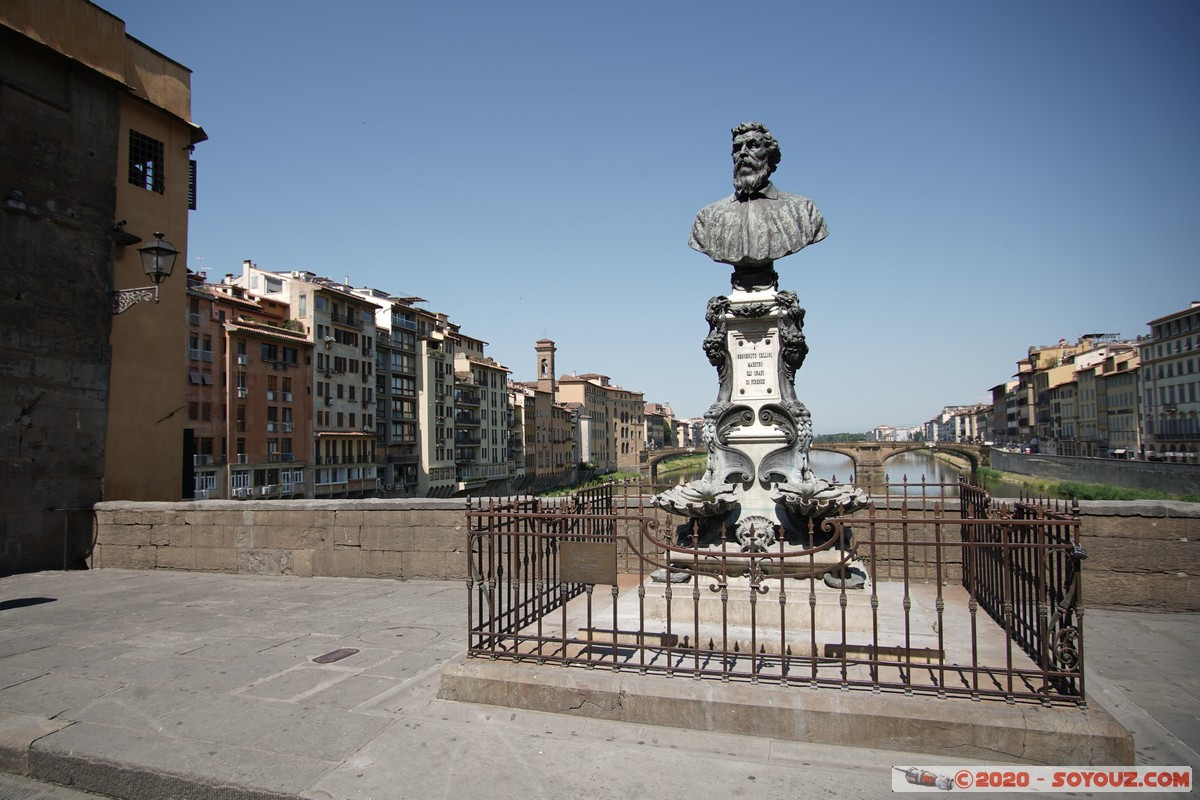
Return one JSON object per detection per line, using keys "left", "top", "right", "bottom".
{"left": 0, "top": 25, "right": 121, "bottom": 576}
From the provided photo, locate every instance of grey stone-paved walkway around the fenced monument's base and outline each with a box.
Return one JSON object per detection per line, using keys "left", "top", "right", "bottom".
{"left": 0, "top": 570, "right": 1200, "bottom": 800}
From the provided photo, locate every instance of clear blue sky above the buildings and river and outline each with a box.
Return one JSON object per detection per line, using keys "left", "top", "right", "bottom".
{"left": 98, "top": 0, "right": 1200, "bottom": 433}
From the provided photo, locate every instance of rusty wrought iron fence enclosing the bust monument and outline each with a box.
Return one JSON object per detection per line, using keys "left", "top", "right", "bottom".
{"left": 468, "top": 482, "right": 1084, "bottom": 704}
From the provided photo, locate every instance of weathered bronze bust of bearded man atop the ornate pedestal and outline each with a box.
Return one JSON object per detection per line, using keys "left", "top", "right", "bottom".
{"left": 688, "top": 122, "right": 829, "bottom": 291}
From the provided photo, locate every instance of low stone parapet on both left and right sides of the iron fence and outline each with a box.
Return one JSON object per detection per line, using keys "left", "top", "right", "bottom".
{"left": 88, "top": 499, "right": 1200, "bottom": 610}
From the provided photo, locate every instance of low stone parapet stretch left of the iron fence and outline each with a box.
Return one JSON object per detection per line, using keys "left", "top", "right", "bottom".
{"left": 90, "top": 499, "right": 467, "bottom": 581}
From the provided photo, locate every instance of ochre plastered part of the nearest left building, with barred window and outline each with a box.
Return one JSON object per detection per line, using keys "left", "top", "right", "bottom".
{"left": 0, "top": 0, "right": 206, "bottom": 500}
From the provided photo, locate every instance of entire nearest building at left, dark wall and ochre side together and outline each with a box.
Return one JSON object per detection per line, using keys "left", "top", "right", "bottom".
{"left": 0, "top": 0, "right": 205, "bottom": 573}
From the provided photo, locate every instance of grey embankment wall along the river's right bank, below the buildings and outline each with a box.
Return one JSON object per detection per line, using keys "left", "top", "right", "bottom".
{"left": 991, "top": 450, "right": 1200, "bottom": 494}
